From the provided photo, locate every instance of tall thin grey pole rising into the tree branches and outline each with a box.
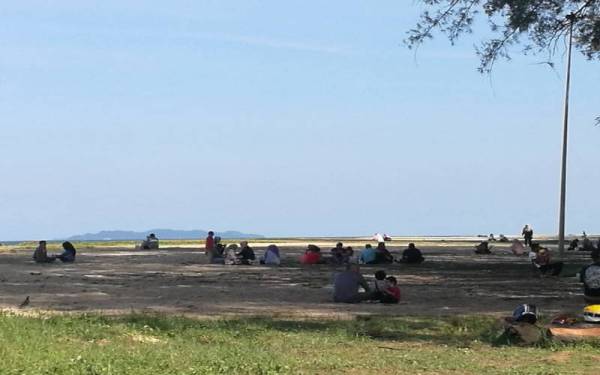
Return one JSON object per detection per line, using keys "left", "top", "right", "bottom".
{"left": 558, "top": 13, "right": 576, "bottom": 257}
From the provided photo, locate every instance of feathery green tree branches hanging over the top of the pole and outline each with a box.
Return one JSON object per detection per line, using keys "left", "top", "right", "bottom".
{"left": 405, "top": 0, "right": 600, "bottom": 73}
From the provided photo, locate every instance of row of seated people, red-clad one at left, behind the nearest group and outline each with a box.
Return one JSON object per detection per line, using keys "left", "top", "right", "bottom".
{"left": 300, "top": 242, "right": 425, "bottom": 265}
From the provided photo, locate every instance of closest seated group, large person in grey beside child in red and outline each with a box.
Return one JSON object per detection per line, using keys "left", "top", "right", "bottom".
{"left": 333, "top": 263, "right": 401, "bottom": 303}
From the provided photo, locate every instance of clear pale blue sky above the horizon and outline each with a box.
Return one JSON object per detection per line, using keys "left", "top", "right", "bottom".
{"left": 0, "top": 0, "right": 600, "bottom": 240}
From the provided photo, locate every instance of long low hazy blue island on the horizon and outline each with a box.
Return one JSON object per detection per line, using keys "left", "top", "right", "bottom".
{"left": 67, "top": 229, "right": 264, "bottom": 241}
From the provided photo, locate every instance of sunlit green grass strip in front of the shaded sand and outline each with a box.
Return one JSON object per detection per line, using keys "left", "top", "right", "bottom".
{"left": 0, "top": 313, "right": 600, "bottom": 375}
